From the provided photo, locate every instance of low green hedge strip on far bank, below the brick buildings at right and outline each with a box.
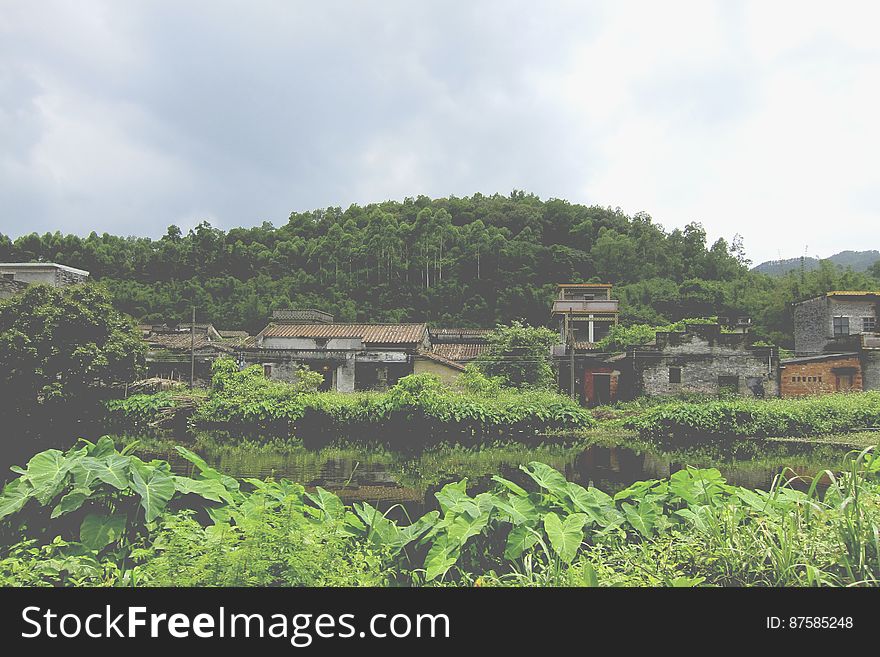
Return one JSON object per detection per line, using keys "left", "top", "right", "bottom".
{"left": 624, "top": 391, "right": 880, "bottom": 439}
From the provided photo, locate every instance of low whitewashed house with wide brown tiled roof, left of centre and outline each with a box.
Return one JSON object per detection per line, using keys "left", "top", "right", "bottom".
{"left": 236, "top": 310, "right": 464, "bottom": 392}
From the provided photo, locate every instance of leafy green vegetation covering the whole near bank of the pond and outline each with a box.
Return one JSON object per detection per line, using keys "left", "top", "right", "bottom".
{"left": 0, "top": 441, "right": 880, "bottom": 586}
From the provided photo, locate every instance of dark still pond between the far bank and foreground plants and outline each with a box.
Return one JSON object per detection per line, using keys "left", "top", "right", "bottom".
{"left": 0, "top": 432, "right": 868, "bottom": 517}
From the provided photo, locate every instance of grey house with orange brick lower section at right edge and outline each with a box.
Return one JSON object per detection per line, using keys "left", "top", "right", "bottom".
{"left": 780, "top": 290, "right": 880, "bottom": 397}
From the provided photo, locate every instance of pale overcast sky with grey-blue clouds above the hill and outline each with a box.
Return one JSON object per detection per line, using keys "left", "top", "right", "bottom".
{"left": 0, "top": 0, "right": 880, "bottom": 262}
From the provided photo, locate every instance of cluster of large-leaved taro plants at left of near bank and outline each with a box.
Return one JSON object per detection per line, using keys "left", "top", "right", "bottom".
{"left": 0, "top": 437, "right": 234, "bottom": 581}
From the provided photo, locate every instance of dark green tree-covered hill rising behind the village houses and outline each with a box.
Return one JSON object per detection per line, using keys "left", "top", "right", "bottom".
{"left": 0, "top": 192, "right": 880, "bottom": 343}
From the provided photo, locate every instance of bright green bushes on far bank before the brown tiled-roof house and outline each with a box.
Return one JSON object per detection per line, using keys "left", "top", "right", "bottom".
{"left": 109, "top": 359, "right": 594, "bottom": 440}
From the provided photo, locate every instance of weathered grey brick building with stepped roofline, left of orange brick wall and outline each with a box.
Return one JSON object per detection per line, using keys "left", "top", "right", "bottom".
{"left": 625, "top": 324, "right": 779, "bottom": 397}
